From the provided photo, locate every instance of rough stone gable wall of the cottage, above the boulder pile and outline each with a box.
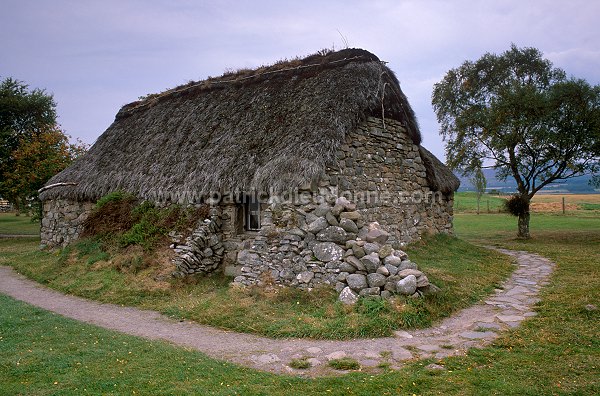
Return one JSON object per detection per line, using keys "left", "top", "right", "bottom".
{"left": 330, "top": 118, "right": 454, "bottom": 243}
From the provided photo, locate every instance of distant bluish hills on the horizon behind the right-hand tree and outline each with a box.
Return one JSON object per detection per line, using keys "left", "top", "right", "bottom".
{"left": 458, "top": 169, "right": 600, "bottom": 194}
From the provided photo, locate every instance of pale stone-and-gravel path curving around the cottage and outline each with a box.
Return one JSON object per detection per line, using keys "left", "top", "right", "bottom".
{"left": 0, "top": 249, "right": 554, "bottom": 377}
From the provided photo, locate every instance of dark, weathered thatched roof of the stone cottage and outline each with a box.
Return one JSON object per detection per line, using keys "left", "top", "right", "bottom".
{"left": 40, "top": 49, "right": 454, "bottom": 202}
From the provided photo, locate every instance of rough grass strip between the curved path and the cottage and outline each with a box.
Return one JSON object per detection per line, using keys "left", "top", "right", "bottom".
{"left": 0, "top": 236, "right": 512, "bottom": 339}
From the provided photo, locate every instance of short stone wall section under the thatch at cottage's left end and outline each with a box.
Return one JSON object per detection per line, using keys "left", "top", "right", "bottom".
{"left": 40, "top": 199, "right": 94, "bottom": 248}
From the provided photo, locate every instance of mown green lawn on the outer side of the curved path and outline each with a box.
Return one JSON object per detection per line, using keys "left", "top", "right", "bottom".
{"left": 0, "top": 210, "right": 600, "bottom": 395}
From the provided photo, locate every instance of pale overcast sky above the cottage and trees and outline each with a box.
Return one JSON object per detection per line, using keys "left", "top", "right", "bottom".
{"left": 0, "top": 0, "right": 600, "bottom": 158}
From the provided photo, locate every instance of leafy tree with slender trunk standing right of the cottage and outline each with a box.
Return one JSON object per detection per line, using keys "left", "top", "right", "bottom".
{"left": 432, "top": 45, "right": 600, "bottom": 238}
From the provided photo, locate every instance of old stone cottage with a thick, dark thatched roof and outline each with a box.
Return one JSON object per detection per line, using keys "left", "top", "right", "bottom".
{"left": 40, "top": 49, "right": 459, "bottom": 292}
